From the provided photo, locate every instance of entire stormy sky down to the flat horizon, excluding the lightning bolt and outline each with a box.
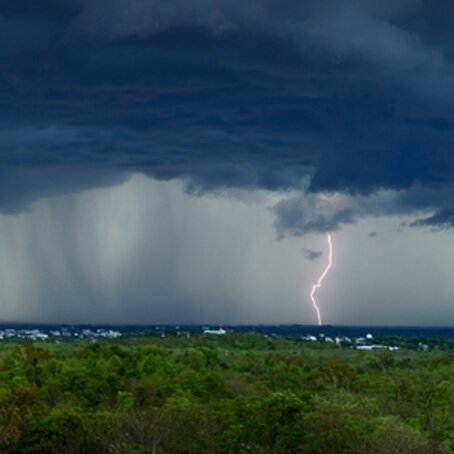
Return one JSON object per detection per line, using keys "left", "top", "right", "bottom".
{"left": 0, "top": 0, "right": 454, "bottom": 325}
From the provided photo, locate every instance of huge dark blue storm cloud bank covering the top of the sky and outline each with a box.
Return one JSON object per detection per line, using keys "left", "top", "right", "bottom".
{"left": 0, "top": 0, "right": 454, "bottom": 231}
